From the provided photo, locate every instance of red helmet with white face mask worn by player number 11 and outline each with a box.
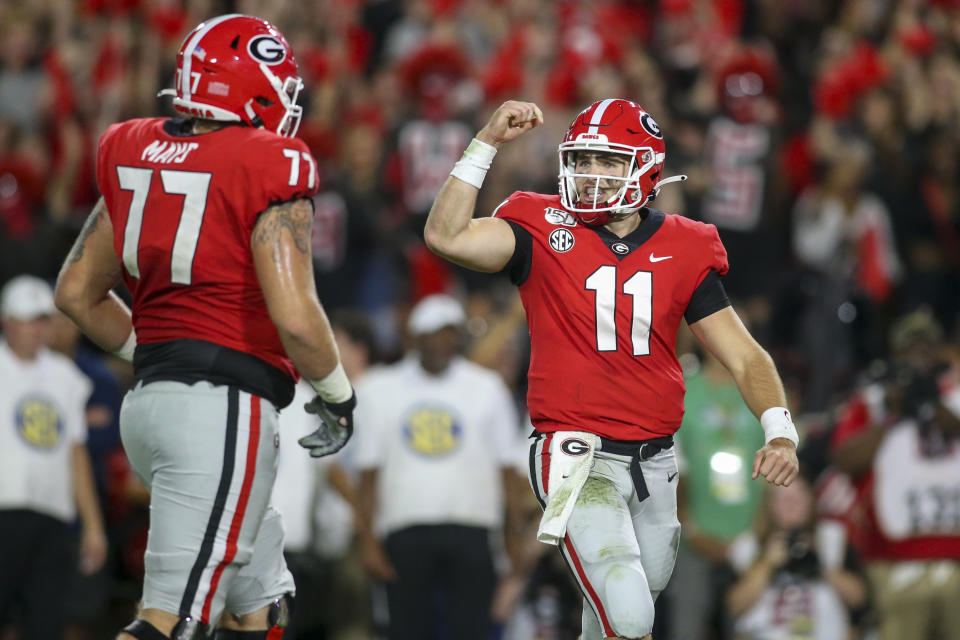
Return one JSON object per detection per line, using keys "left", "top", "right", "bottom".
{"left": 559, "top": 99, "right": 686, "bottom": 225}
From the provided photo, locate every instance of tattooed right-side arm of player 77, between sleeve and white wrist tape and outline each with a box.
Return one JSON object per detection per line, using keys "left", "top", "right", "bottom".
{"left": 250, "top": 199, "right": 340, "bottom": 380}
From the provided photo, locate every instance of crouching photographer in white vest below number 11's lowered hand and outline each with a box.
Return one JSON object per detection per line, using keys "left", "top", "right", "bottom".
{"left": 726, "top": 477, "right": 868, "bottom": 640}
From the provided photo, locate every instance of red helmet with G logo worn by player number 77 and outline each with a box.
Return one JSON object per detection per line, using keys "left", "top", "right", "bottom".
{"left": 159, "top": 13, "right": 303, "bottom": 137}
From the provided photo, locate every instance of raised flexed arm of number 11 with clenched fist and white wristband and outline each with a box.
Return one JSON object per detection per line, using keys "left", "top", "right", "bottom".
{"left": 423, "top": 100, "right": 543, "bottom": 273}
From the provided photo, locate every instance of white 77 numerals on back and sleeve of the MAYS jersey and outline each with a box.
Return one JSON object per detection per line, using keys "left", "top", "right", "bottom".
{"left": 117, "top": 149, "right": 317, "bottom": 285}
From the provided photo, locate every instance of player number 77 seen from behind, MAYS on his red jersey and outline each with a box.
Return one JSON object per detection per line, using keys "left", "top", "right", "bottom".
{"left": 56, "top": 15, "right": 355, "bottom": 640}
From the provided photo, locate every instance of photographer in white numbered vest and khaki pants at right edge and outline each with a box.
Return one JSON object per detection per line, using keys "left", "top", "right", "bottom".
{"left": 831, "top": 311, "right": 960, "bottom": 640}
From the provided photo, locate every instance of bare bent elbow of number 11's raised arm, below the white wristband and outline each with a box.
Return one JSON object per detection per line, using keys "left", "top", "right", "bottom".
{"left": 423, "top": 176, "right": 516, "bottom": 273}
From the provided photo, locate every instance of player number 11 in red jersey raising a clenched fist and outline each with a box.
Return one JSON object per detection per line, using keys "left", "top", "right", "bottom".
{"left": 424, "top": 99, "right": 799, "bottom": 640}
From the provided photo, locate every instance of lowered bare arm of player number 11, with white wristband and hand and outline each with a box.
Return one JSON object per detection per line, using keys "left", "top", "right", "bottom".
{"left": 690, "top": 307, "right": 800, "bottom": 485}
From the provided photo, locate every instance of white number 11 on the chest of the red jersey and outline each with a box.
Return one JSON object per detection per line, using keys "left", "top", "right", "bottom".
{"left": 584, "top": 264, "right": 653, "bottom": 356}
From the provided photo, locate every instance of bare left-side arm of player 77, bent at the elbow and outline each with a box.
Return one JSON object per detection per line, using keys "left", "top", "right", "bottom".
{"left": 55, "top": 198, "right": 133, "bottom": 351}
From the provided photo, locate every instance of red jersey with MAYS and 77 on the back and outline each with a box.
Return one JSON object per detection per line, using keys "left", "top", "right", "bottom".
{"left": 97, "top": 118, "right": 318, "bottom": 377}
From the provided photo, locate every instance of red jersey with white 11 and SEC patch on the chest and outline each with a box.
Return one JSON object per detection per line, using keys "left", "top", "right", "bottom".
{"left": 494, "top": 192, "right": 728, "bottom": 440}
